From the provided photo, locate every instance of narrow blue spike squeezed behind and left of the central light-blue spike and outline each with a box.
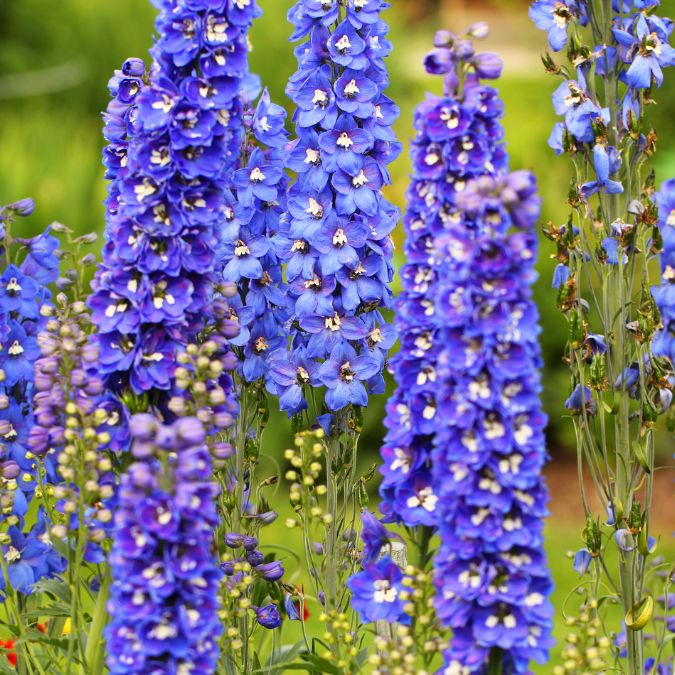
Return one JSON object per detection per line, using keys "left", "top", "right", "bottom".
{"left": 219, "top": 89, "right": 288, "bottom": 388}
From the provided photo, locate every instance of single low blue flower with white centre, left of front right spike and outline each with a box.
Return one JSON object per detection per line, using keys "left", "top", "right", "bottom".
{"left": 347, "top": 556, "right": 410, "bottom": 623}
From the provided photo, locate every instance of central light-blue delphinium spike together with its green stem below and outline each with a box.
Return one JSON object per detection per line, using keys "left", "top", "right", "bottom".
{"left": 278, "top": 0, "right": 401, "bottom": 669}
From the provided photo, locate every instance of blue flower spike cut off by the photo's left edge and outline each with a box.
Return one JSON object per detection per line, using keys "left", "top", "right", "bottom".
{"left": 0, "top": 199, "right": 65, "bottom": 603}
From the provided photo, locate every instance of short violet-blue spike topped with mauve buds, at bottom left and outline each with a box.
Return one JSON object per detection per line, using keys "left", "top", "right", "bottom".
{"left": 106, "top": 415, "right": 222, "bottom": 673}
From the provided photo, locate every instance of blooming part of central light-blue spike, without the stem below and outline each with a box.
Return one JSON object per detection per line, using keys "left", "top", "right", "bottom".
{"left": 271, "top": 0, "right": 400, "bottom": 414}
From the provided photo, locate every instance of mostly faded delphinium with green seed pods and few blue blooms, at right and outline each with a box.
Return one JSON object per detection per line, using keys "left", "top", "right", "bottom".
{"left": 531, "top": 0, "right": 675, "bottom": 675}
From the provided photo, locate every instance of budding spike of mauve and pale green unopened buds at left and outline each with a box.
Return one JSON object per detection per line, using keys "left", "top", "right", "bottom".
{"left": 28, "top": 294, "right": 129, "bottom": 566}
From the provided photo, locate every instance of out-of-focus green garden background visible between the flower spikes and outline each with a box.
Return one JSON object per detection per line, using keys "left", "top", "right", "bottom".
{"left": 0, "top": 0, "right": 675, "bottom": 672}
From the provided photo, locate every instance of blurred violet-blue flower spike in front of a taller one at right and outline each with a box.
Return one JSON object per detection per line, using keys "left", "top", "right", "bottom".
{"left": 432, "top": 177, "right": 553, "bottom": 673}
